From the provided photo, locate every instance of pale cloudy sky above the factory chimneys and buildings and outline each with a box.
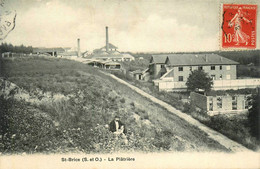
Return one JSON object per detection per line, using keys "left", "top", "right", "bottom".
{"left": 0, "top": 0, "right": 260, "bottom": 52}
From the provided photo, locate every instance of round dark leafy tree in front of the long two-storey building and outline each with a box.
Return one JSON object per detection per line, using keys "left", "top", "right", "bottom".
{"left": 186, "top": 70, "right": 213, "bottom": 92}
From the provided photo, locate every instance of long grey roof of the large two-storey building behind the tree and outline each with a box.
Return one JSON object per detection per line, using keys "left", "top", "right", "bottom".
{"left": 152, "top": 54, "right": 239, "bottom": 66}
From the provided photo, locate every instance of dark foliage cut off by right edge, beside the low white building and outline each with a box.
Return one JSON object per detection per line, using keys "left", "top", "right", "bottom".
{"left": 248, "top": 89, "right": 260, "bottom": 140}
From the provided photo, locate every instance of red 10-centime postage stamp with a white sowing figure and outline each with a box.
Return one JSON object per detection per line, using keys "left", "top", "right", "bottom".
{"left": 221, "top": 4, "right": 257, "bottom": 49}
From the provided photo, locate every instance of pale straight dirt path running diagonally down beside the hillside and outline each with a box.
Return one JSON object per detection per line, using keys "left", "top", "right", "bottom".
{"left": 100, "top": 71, "right": 251, "bottom": 152}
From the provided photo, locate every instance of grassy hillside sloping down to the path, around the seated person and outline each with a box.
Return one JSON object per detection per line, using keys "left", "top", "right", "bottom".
{"left": 0, "top": 57, "right": 228, "bottom": 153}
